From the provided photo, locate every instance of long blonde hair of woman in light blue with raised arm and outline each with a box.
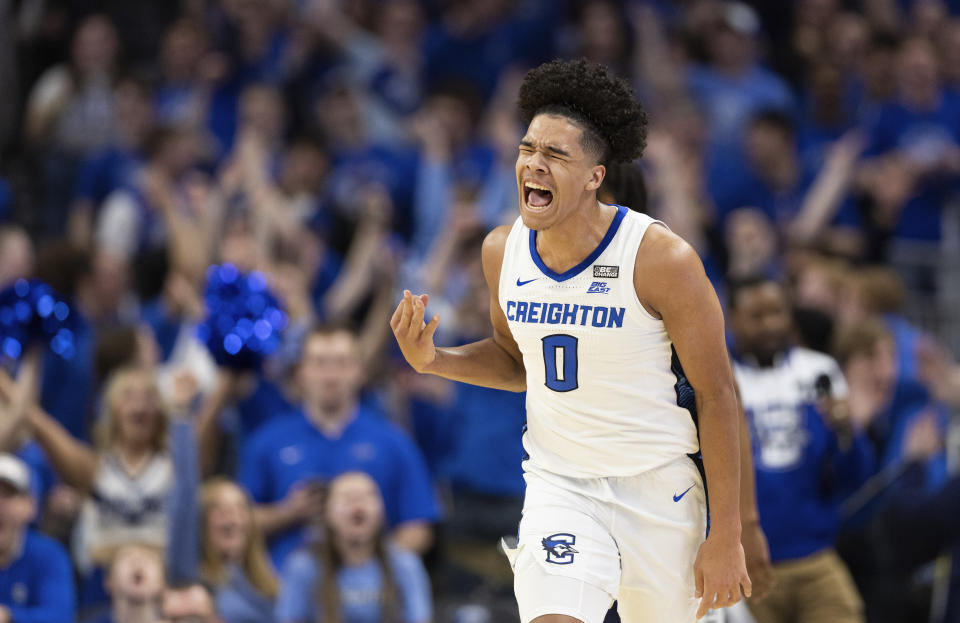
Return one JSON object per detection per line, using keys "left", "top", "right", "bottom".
{"left": 200, "top": 477, "right": 278, "bottom": 599}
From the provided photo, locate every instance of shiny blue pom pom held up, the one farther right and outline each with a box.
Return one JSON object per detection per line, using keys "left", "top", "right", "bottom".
{"left": 197, "top": 264, "right": 287, "bottom": 370}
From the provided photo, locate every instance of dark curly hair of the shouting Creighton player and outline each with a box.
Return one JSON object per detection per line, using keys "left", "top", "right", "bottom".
{"left": 518, "top": 58, "right": 647, "bottom": 164}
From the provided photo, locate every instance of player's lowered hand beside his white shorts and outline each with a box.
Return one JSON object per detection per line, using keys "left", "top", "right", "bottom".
{"left": 693, "top": 533, "right": 753, "bottom": 619}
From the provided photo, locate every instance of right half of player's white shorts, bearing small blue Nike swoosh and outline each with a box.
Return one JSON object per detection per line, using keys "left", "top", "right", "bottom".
{"left": 609, "top": 457, "right": 707, "bottom": 623}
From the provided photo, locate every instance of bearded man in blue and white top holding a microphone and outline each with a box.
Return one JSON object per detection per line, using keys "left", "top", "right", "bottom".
{"left": 728, "top": 278, "right": 874, "bottom": 623}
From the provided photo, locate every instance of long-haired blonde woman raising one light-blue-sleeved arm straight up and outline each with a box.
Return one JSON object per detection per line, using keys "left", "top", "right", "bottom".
{"left": 167, "top": 376, "right": 277, "bottom": 623}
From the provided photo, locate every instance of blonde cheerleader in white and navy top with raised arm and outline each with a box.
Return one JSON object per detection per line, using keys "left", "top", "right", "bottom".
{"left": 0, "top": 364, "right": 173, "bottom": 608}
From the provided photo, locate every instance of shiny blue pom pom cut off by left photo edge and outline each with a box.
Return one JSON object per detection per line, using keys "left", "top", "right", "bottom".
{"left": 0, "top": 279, "right": 76, "bottom": 360}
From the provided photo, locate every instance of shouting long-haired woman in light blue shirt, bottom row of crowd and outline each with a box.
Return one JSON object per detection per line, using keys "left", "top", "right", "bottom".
{"left": 276, "top": 472, "right": 432, "bottom": 623}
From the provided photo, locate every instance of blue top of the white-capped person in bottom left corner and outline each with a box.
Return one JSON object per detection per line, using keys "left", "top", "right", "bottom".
{"left": 0, "top": 531, "right": 76, "bottom": 623}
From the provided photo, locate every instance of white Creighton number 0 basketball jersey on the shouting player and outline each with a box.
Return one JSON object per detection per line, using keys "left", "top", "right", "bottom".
{"left": 499, "top": 206, "right": 699, "bottom": 478}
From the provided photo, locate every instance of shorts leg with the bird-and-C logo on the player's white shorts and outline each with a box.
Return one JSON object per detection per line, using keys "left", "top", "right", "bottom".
{"left": 504, "top": 473, "right": 620, "bottom": 623}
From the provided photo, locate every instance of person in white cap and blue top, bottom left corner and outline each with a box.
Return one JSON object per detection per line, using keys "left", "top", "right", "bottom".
{"left": 0, "top": 453, "right": 76, "bottom": 623}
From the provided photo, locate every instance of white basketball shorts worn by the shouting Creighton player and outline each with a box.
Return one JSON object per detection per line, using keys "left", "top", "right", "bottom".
{"left": 504, "top": 456, "right": 707, "bottom": 623}
